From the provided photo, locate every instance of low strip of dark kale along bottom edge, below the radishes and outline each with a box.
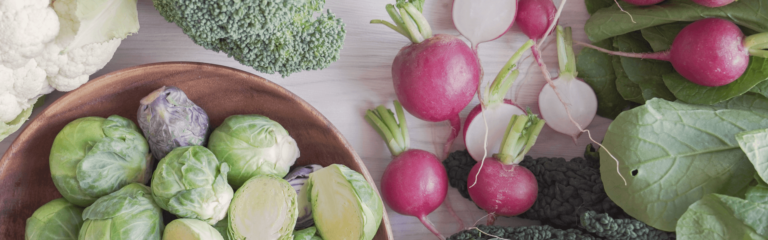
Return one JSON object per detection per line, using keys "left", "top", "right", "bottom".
{"left": 448, "top": 225, "right": 600, "bottom": 240}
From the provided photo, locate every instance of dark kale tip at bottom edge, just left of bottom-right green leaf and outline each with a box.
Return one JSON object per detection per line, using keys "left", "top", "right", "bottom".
{"left": 580, "top": 211, "right": 675, "bottom": 240}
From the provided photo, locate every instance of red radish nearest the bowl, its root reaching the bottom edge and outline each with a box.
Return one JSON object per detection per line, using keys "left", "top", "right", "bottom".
{"left": 365, "top": 101, "right": 448, "bottom": 239}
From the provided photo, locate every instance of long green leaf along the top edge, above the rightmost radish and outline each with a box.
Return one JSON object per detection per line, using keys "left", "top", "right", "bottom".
{"left": 584, "top": 0, "right": 768, "bottom": 42}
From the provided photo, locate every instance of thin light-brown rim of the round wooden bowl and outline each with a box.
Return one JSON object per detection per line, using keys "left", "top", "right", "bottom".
{"left": 0, "top": 61, "right": 394, "bottom": 239}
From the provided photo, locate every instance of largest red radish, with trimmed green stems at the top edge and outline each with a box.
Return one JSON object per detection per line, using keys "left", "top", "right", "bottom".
{"left": 371, "top": 0, "right": 480, "bottom": 156}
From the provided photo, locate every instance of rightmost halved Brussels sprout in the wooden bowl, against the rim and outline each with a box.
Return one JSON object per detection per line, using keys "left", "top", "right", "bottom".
{"left": 306, "top": 164, "right": 384, "bottom": 240}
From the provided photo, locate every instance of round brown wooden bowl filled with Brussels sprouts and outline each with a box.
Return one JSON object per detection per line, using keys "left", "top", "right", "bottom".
{"left": 0, "top": 62, "right": 392, "bottom": 240}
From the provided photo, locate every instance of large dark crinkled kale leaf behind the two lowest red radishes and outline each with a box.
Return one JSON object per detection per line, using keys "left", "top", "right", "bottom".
{"left": 443, "top": 145, "right": 629, "bottom": 229}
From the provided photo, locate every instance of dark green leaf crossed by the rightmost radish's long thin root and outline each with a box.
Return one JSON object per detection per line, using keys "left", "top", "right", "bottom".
{"left": 614, "top": 31, "right": 675, "bottom": 101}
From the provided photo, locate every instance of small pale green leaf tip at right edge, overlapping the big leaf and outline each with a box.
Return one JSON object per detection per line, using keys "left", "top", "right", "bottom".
{"left": 736, "top": 129, "right": 768, "bottom": 184}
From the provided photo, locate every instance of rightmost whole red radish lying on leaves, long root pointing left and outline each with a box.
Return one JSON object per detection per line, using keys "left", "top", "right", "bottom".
{"left": 579, "top": 18, "right": 768, "bottom": 87}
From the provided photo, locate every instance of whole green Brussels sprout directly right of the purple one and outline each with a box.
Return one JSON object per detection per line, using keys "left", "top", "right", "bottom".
{"left": 208, "top": 115, "right": 299, "bottom": 189}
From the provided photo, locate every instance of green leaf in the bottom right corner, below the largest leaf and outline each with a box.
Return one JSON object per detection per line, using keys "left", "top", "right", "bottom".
{"left": 677, "top": 194, "right": 768, "bottom": 240}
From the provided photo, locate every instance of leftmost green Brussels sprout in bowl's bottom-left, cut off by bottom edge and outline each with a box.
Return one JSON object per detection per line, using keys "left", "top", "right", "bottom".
{"left": 24, "top": 198, "right": 83, "bottom": 240}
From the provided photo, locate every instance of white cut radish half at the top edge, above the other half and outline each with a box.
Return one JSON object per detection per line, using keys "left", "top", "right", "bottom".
{"left": 451, "top": 0, "right": 517, "bottom": 51}
